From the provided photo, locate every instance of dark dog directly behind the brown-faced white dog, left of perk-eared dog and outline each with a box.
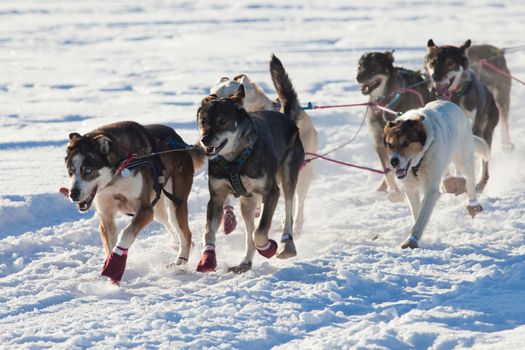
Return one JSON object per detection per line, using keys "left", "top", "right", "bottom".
{"left": 357, "top": 51, "right": 434, "bottom": 202}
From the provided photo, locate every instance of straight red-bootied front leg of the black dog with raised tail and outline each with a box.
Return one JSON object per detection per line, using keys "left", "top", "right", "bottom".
{"left": 193, "top": 187, "right": 227, "bottom": 272}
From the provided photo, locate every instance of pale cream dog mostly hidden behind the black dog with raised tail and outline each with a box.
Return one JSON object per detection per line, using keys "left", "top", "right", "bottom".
{"left": 210, "top": 74, "right": 318, "bottom": 234}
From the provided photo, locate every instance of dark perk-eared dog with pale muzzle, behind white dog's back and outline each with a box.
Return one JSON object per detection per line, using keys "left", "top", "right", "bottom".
{"left": 425, "top": 39, "right": 499, "bottom": 192}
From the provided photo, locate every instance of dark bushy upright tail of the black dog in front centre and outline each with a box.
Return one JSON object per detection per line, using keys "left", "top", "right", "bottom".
{"left": 270, "top": 55, "right": 302, "bottom": 122}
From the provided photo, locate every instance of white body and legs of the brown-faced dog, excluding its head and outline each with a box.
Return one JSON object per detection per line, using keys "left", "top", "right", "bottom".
{"left": 392, "top": 101, "right": 488, "bottom": 245}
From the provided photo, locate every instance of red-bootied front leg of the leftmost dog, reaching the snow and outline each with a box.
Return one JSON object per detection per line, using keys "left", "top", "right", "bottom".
{"left": 101, "top": 205, "right": 153, "bottom": 284}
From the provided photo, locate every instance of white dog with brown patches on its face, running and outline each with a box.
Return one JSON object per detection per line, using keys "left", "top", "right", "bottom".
{"left": 384, "top": 101, "right": 490, "bottom": 249}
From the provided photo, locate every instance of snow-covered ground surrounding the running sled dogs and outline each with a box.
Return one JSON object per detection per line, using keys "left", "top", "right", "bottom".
{"left": 0, "top": 0, "right": 525, "bottom": 349}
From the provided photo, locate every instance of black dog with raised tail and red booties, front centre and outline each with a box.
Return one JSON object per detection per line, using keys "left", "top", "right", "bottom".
{"left": 197, "top": 56, "right": 304, "bottom": 273}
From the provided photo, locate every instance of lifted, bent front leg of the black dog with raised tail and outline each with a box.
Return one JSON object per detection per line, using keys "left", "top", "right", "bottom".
{"left": 253, "top": 182, "right": 279, "bottom": 259}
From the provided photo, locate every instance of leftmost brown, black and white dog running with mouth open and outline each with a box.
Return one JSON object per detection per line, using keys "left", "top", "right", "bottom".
{"left": 63, "top": 121, "right": 204, "bottom": 284}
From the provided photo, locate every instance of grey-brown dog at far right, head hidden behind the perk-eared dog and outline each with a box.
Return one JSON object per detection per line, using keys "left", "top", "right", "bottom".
{"left": 467, "top": 45, "right": 514, "bottom": 152}
